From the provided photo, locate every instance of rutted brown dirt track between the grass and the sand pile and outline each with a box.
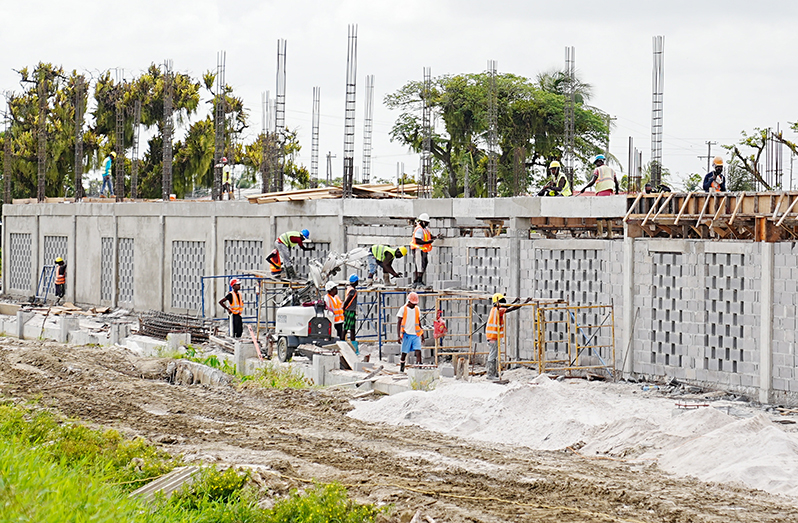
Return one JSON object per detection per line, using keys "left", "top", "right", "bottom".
{"left": 0, "top": 338, "right": 798, "bottom": 522}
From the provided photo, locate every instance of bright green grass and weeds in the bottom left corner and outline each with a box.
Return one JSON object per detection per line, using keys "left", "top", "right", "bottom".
{"left": 0, "top": 402, "right": 389, "bottom": 523}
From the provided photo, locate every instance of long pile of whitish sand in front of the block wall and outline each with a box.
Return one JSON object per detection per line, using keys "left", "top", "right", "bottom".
{"left": 350, "top": 376, "right": 798, "bottom": 496}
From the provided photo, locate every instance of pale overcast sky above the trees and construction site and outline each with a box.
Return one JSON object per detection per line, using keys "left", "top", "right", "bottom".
{"left": 0, "top": 0, "right": 798, "bottom": 190}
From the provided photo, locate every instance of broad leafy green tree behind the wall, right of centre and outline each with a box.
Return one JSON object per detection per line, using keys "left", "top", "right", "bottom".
{"left": 385, "top": 73, "right": 607, "bottom": 197}
